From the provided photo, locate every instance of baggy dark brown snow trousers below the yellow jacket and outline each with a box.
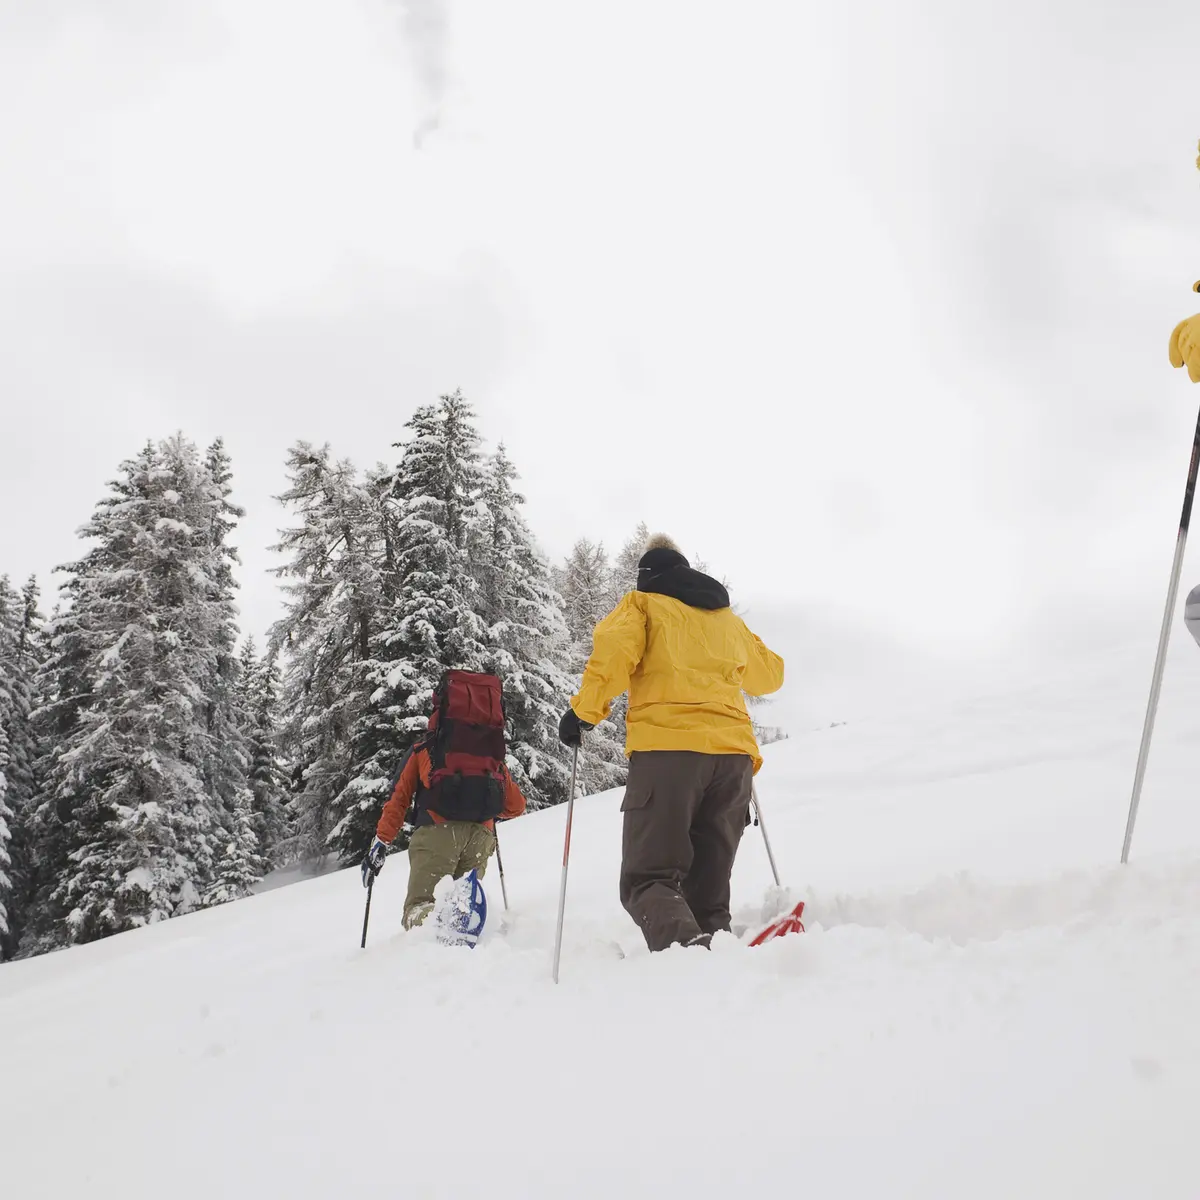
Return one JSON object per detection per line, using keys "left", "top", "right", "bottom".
{"left": 620, "top": 750, "right": 754, "bottom": 950}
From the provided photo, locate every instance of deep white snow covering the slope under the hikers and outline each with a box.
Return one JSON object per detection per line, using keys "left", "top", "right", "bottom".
{"left": 0, "top": 636, "right": 1200, "bottom": 1200}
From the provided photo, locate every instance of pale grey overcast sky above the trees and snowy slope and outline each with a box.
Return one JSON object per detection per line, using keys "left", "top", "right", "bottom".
{"left": 0, "top": 0, "right": 1200, "bottom": 720}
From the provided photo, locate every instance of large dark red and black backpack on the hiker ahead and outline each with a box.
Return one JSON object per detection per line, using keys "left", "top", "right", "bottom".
{"left": 420, "top": 671, "right": 505, "bottom": 821}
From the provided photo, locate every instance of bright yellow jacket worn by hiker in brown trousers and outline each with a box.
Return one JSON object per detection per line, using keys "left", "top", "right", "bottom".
{"left": 571, "top": 592, "right": 784, "bottom": 773}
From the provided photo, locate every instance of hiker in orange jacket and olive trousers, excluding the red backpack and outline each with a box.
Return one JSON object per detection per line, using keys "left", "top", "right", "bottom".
{"left": 362, "top": 744, "right": 526, "bottom": 929}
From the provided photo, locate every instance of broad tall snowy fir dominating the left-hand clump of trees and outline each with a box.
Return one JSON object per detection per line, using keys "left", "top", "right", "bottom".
{"left": 24, "top": 437, "right": 238, "bottom": 946}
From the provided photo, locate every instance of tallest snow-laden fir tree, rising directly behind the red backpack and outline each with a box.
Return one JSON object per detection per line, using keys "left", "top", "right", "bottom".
{"left": 330, "top": 391, "right": 487, "bottom": 860}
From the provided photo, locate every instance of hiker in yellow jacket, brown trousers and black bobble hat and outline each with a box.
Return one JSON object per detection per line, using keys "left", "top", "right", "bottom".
{"left": 558, "top": 534, "right": 784, "bottom": 950}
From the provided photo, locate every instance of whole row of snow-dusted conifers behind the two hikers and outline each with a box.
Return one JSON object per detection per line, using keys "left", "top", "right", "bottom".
{"left": 0, "top": 392, "right": 681, "bottom": 958}
